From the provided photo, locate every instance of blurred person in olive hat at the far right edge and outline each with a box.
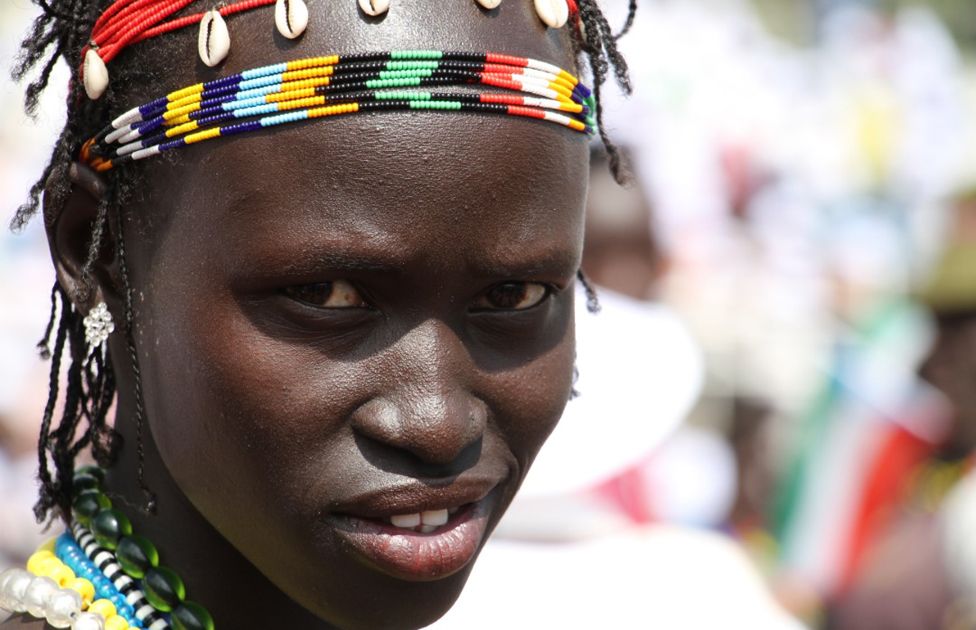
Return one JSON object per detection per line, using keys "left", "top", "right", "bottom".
{"left": 829, "top": 190, "right": 976, "bottom": 630}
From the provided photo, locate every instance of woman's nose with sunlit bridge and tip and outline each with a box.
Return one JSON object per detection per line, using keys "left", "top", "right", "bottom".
{"left": 352, "top": 321, "right": 488, "bottom": 477}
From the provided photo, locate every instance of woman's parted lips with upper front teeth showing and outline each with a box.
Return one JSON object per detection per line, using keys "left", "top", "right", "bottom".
{"left": 329, "top": 479, "right": 499, "bottom": 582}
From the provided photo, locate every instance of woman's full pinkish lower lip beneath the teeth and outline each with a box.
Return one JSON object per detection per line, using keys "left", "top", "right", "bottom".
{"left": 335, "top": 497, "right": 490, "bottom": 582}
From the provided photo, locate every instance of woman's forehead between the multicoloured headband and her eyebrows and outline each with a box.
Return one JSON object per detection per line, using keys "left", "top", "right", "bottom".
{"left": 157, "top": 114, "right": 586, "bottom": 276}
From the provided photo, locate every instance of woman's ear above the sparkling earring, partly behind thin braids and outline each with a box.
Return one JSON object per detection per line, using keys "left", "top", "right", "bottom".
{"left": 44, "top": 162, "right": 119, "bottom": 314}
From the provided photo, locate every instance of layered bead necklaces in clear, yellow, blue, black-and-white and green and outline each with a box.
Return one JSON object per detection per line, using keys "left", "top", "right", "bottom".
{"left": 0, "top": 467, "right": 214, "bottom": 630}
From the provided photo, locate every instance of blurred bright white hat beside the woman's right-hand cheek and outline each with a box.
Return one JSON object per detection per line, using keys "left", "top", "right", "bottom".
{"left": 516, "top": 289, "right": 704, "bottom": 501}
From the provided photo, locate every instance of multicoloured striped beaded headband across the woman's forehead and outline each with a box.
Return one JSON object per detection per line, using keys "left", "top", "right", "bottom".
{"left": 81, "top": 50, "right": 596, "bottom": 171}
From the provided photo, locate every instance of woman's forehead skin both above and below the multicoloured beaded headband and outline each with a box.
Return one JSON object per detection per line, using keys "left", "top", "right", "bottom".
{"left": 127, "top": 1, "right": 587, "bottom": 256}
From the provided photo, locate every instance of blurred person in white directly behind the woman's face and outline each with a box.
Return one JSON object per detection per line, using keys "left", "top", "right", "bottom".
{"left": 434, "top": 149, "right": 799, "bottom": 630}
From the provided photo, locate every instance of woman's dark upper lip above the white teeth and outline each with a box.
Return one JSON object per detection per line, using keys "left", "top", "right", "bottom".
{"left": 329, "top": 476, "right": 502, "bottom": 518}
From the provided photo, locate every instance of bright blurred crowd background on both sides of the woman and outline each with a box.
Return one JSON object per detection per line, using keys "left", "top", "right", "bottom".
{"left": 0, "top": 0, "right": 976, "bottom": 630}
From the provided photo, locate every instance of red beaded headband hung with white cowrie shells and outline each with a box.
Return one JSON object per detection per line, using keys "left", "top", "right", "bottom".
{"left": 81, "top": 0, "right": 579, "bottom": 100}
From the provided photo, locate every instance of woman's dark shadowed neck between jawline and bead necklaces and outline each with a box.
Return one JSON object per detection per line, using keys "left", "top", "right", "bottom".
{"left": 105, "top": 396, "right": 329, "bottom": 628}
